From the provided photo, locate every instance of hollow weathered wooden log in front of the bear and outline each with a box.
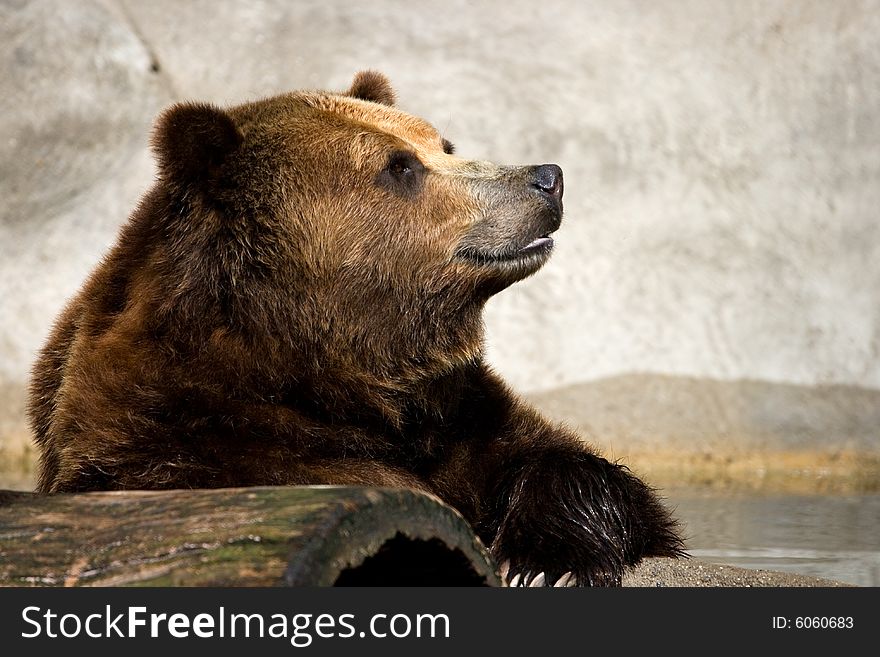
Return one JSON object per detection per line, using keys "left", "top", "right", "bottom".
{"left": 0, "top": 486, "right": 502, "bottom": 586}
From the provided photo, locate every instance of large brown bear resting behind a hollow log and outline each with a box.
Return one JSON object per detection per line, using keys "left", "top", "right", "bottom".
{"left": 29, "top": 71, "right": 682, "bottom": 585}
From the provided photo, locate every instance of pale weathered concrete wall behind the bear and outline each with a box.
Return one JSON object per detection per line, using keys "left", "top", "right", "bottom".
{"left": 0, "top": 0, "right": 880, "bottom": 472}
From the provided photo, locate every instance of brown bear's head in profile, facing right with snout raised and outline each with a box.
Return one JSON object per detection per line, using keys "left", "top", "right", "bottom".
{"left": 140, "top": 71, "right": 562, "bottom": 400}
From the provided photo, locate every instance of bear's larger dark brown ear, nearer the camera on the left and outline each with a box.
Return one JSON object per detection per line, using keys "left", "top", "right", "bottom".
{"left": 153, "top": 103, "right": 243, "bottom": 184}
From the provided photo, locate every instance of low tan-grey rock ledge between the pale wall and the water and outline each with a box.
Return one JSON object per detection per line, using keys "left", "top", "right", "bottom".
{"left": 528, "top": 374, "right": 880, "bottom": 491}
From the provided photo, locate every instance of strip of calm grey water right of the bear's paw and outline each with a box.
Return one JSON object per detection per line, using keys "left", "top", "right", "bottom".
{"left": 664, "top": 489, "right": 880, "bottom": 586}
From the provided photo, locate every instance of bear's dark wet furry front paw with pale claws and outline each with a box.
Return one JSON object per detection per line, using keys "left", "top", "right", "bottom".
{"left": 491, "top": 452, "right": 685, "bottom": 586}
